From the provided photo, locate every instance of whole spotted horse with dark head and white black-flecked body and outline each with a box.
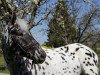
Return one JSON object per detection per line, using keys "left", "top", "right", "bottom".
{"left": 2, "top": 15, "right": 98, "bottom": 75}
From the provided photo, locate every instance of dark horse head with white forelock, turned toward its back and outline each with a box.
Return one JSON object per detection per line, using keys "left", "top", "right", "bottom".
{"left": 8, "top": 18, "right": 46, "bottom": 64}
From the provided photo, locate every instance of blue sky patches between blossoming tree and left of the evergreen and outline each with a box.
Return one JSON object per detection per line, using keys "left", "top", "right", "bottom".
{"left": 31, "top": 0, "right": 57, "bottom": 45}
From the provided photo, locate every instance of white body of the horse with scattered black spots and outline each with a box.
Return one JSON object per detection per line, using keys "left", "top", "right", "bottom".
{"left": 24, "top": 43, "right": 99, "bottom": 75}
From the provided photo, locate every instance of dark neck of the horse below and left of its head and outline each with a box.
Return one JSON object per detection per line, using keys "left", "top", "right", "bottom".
{"left": 2, "top": 26, "right": 31, "bottom": 75}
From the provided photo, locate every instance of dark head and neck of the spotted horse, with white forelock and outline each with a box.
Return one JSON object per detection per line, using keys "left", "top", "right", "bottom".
{"left": 1, "top": 13, "right": 46, "bottom": 75}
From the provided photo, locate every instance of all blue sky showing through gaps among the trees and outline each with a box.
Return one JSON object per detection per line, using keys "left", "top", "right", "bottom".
{"left": 31, "top": 0, "right": 100, "bottom": 45}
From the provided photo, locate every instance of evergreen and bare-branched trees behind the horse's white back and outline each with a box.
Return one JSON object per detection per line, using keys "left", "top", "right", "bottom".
{"left": 46, "top": 0, "right": 100, "bottom": 49}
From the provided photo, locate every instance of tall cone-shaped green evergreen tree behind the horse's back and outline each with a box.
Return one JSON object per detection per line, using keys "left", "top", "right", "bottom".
{"left": 46, "top": 0, "right": 76, "bottom": 47}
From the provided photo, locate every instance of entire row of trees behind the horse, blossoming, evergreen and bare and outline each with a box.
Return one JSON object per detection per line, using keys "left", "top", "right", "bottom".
{"left": 0, "top": 0, "right": 100, "bottom": 48}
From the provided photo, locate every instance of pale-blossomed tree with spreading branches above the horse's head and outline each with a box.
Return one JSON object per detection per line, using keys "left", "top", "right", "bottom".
{"left": 0, "top": 0, "right": 51, "bottom": 29}
